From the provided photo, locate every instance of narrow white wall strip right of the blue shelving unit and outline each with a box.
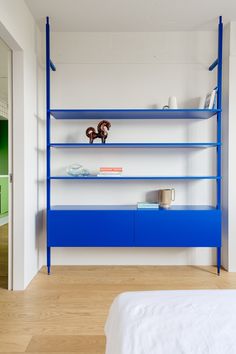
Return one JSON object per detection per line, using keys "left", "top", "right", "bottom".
{"left": 223, "top": 22, "right": 236, "bottom": 272}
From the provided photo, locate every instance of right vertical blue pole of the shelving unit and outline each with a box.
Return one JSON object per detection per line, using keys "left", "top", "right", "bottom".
{"left": 217, "top": 16, "right": 223, "bottom": 275}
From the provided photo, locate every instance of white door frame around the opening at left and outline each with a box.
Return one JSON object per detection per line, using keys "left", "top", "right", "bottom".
{"left": 0, "top": 21, "right": 25, "bottom": 290}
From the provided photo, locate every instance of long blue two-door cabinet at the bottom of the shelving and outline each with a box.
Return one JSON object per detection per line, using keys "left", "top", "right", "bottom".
{"left": 47, "top": 206, "right": 221, "bottom": 247}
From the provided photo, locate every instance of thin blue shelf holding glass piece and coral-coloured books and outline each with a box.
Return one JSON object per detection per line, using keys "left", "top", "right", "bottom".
{"left": 48, "top": 176, "right": 221, "bottom": 180}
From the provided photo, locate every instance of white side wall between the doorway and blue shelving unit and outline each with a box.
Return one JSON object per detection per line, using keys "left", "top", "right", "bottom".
{"left": 0, "top": 0, "right": 40, "bottom": 289}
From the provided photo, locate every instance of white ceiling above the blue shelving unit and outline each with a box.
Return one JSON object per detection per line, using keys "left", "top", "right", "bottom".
{"left": 25, "top": 0, "right": 236, "bottom": 32}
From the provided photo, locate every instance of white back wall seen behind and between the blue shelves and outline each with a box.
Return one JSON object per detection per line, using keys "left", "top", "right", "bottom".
{"left": 40, "top": 32, "right": 217, "bottom": 264}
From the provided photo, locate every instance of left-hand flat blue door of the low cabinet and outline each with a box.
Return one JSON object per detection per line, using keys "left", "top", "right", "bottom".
{"left": 47, "top": 210, "right": 134, "bottom": 247}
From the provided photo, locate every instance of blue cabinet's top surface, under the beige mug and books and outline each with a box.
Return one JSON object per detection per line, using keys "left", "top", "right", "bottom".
{"left": 51, "top": 205, "right": 216, "bottom": 212}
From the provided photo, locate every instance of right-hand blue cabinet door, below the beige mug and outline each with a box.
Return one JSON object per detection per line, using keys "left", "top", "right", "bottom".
{"left": 135, "top": 209, "right": 221, "bottom": 247}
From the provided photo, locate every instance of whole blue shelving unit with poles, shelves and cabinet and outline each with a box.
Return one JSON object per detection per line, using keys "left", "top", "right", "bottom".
{"left": 46, "top": 16, "right": 223, "bottom": 274}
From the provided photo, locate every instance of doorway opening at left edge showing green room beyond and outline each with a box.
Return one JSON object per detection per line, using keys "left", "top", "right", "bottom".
{"left": 0, "top": 38, "right": 12, "bottom": 289}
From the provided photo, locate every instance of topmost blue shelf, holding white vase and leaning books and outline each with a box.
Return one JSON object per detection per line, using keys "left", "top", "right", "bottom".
{"left": 49, "top": 109, "right": 221, "bottom": 120}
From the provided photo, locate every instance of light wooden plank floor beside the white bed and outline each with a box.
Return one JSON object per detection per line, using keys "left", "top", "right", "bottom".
{"left": 0, "top": 266, "right": 236, "bottom": 354}
